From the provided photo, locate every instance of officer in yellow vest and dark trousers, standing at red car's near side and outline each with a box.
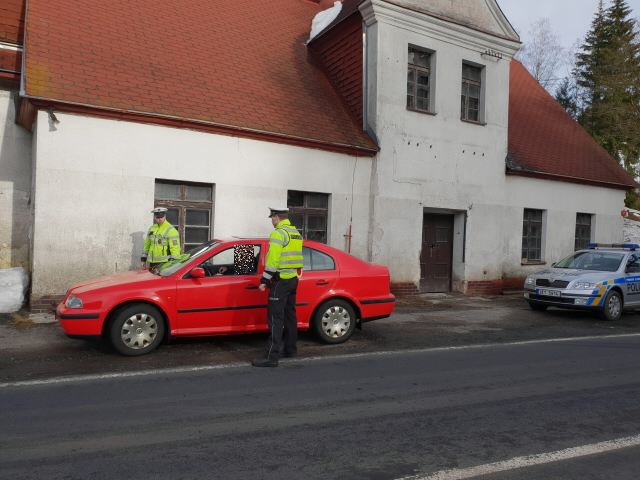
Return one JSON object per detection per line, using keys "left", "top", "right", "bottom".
{"left": 251, "top": 207, "right": 302, "bottom": 367}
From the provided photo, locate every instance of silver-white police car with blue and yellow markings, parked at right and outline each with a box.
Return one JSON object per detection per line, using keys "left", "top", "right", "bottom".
{"left": 524, "top": 243, "right": 640, "bottom": 320}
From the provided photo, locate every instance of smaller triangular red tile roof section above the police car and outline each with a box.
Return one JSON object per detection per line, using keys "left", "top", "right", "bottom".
{"left": 507, "top": 60, "right": 637, "bottom": 189}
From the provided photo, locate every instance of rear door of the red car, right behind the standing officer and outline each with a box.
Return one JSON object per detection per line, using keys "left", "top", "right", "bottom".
{"left": 296, "top": 246, "right": 340, "bottom": 328}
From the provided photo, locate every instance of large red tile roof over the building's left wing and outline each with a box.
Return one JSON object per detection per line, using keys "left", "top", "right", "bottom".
{"left": 25, "top": 0, "right": 377, "bottom": 155}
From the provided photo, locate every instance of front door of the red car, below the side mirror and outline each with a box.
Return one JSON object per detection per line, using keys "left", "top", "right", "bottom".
{"left": 176, "top": 244, "right": 267, "bottom": 335}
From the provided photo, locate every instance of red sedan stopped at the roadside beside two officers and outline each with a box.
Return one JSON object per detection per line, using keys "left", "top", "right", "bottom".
{"left": 56, "top": 238, "right": 395, "bottom": 355}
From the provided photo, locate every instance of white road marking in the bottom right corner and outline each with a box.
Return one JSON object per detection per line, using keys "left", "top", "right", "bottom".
{"left": 398, "top": 435, "right": 640, "bottom": 480}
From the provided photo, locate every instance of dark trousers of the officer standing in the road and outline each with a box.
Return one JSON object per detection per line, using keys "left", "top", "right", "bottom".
{"left": 266, "top": 277, "right": 298, "bottom": 361}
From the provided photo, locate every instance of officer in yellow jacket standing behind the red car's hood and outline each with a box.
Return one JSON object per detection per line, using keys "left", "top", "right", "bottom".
{"left": 140, "top": 207, "right": 180, "bottom": 268}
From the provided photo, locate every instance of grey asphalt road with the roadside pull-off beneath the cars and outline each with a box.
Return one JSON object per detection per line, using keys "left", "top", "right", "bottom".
{"left": 0, "top": 295, "right": 640, "bottom": 480}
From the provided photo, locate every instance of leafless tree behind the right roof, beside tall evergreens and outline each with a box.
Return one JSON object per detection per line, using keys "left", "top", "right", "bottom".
{"left": 516, "top": 18, "right": 568, "bottom": 92}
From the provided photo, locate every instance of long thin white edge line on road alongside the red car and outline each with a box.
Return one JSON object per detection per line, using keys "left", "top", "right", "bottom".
{"left": 0, "top": 333, "right": 640, "bottom": 388}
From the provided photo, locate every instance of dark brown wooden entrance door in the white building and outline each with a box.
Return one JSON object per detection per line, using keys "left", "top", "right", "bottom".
{"left": 420, "top": 213, "right": 453, "bottom": 293}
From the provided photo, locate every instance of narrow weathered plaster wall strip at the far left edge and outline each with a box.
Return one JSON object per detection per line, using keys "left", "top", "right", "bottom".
{"left": 0, "top": 89, "right": 32, "bottom": 270}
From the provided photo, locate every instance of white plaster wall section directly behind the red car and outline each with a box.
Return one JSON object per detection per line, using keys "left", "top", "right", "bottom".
{"left": 32, "top": 111, "right": 371, "bottom": 298}
